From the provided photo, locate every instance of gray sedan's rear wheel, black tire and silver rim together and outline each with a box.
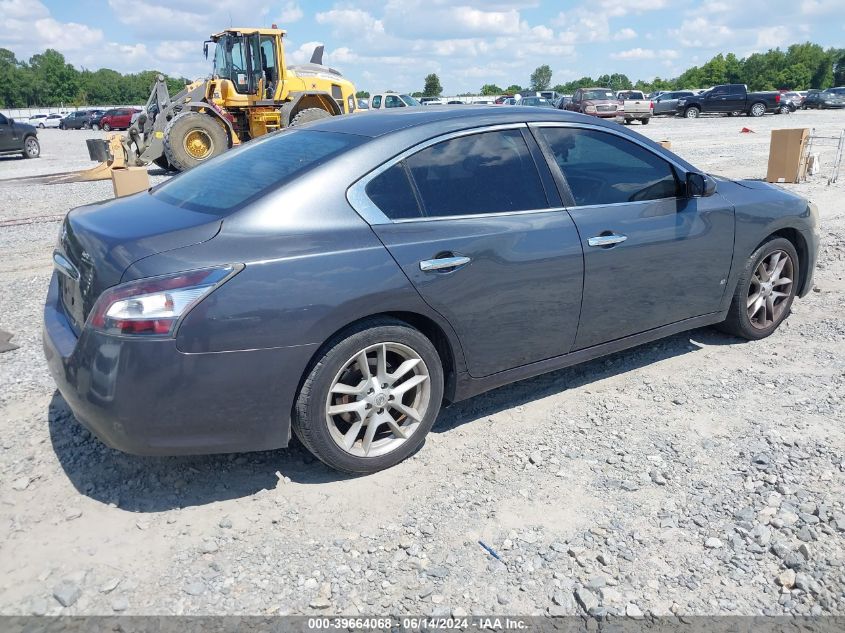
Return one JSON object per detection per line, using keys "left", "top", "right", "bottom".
{"left": 293, "top": 318, "right": 443, "bottom": 475}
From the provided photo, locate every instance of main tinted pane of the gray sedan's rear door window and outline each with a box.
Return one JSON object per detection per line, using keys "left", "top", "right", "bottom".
{"left": 407, "top": 130, "right": 548, "bottom": 217}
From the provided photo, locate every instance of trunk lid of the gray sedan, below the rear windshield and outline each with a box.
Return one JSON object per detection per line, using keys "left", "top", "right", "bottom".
{"left": 54, "top": 192, "right": 222, "bottom": 334}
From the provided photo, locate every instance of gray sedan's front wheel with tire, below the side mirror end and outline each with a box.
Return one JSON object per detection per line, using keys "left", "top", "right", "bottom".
{"left": 718, "top": 237, "right": 800, "bottom": 340}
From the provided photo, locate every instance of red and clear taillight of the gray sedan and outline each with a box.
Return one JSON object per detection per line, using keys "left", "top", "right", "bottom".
{"left": 88, "top": 265, "right": 242, "bottom": 336}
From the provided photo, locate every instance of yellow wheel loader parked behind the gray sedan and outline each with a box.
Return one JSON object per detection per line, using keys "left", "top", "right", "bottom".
{"left": 80, "top": 25, "right": 356, "bottom": 182}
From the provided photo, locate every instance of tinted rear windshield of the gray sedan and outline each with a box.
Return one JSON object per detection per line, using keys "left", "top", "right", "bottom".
{"left": 152, "top": 130, "right": 364, "bottom": 217}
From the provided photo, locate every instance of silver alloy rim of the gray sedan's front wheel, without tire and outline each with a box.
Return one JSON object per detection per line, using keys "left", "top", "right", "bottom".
{"left": 746, "top": 250, "right": 795, "bottom": 330}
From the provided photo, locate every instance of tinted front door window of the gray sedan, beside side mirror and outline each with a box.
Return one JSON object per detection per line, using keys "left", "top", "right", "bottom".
{"left": 541, "top": 128, "right": 679, "bottom": 206}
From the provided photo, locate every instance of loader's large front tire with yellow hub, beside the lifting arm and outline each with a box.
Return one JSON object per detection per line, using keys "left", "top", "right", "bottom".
{"left": 164, "top": 112, "right": 229, "bottom": 171}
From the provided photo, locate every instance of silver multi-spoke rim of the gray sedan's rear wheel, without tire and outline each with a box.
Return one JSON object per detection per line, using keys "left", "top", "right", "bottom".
{"left": 326, "top": 342, "right": 431, "bottom": 457}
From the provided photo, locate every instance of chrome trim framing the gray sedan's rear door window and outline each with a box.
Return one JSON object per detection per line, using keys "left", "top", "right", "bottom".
{"left": 346, "top": 122, "right": 552, "bottom": 226}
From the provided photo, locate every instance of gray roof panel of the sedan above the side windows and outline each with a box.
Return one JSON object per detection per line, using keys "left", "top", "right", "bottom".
{"left": 308, "top": 105, "right": 610, "bottom": 138}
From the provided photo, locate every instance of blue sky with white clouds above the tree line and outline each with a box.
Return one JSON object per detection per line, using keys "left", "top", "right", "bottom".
{"left": 0, "top": 0, "right": 845, "bottom": 94}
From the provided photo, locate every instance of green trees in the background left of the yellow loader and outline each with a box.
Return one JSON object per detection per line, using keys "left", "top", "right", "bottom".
{"left": 0, "top": 48, "right": 186, "bottom": 108}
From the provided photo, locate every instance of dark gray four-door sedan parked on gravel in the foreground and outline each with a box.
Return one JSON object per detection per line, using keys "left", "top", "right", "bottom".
{"left": 44, "top": 106, "right": 818, "bottom": 473}
